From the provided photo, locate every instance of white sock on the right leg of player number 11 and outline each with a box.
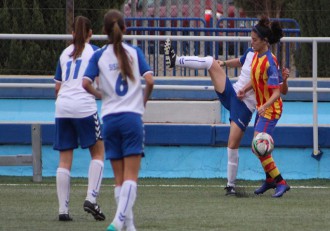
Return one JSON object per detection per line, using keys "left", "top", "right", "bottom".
{"left": 86, "top": 160, "right": 104, "bottom": 203}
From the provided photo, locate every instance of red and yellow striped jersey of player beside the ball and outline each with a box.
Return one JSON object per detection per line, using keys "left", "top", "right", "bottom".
{"left": 251, "top": 50, "right": 283, "bottom": 119}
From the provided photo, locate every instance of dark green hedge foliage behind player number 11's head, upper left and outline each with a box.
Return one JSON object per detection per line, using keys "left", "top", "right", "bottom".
{"left": 0, "top": 0, "right": 124, "bottom": 75}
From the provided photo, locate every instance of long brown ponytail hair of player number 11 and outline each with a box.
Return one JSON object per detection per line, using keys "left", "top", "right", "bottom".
{"left": 70, "top": 16, "right": 92, "bottom": 59}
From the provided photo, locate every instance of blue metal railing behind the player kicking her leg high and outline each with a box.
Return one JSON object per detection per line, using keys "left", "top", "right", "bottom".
{"left": 126, "top": 17, "right": 300, "bottom": 76}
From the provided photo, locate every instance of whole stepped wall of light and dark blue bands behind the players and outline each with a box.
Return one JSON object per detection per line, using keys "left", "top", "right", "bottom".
{"left": 0, "top": 78, "right": 330, "bottom": 180}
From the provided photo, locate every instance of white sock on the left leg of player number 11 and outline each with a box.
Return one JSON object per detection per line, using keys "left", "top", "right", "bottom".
{"left": 56, "top": 168, "right": 70, "bottom": 214}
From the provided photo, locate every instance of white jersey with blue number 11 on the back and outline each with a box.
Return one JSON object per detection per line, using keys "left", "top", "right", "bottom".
{"left": 54, "top": 43, "right": 97, "bottom": 118}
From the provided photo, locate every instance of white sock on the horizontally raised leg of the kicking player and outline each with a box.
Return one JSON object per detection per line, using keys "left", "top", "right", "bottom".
{"left": 175, "top": 56, "right": 213, "bottom": 70}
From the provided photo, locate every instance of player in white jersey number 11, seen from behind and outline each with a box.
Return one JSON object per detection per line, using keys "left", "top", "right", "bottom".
{"left": 54, "top": 16, "right": 105, "bottom": 221}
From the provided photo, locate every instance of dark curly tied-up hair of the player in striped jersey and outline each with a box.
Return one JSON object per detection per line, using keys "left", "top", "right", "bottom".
{"left": 252, "top": 16, "right": 283, "bottom": 44}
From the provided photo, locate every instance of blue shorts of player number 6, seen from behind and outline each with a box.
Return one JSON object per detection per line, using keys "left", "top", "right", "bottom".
{"left": 102, "top": 112, "right": 144, "bottom": 160}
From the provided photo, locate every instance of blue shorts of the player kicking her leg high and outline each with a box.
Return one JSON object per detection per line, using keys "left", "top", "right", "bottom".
{"left": 216, "top": 77, "right": 252, "bottom": 131}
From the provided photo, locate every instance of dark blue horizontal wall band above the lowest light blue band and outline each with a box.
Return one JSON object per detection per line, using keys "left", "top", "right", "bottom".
{"left": 0, "top": 123, "right": 330, "bottom": 148}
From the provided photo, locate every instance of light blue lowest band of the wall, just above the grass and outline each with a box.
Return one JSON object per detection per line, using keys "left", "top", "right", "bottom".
{"left": 0, "top": 145, "right": 330, "bottom": 180}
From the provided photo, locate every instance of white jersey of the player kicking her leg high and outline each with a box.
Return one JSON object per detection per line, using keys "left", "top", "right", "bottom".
{"left": 233, "top": 48, "right": 257, "bottom": 113}
